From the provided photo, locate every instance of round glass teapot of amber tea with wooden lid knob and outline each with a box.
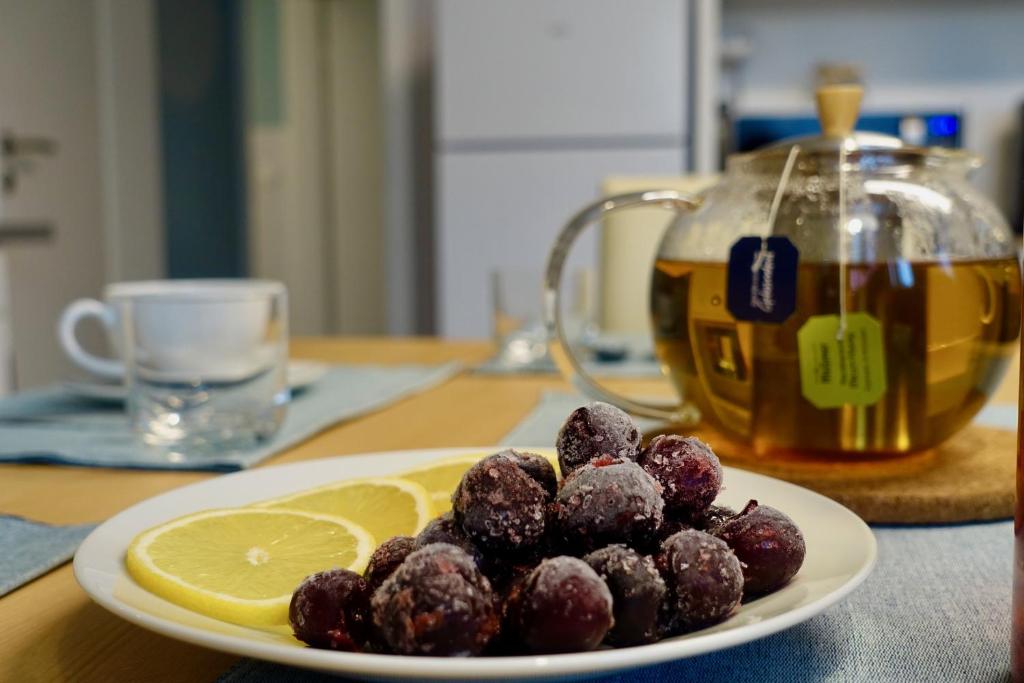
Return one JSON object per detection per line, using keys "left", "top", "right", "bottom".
{"left": 545, "top": 86, "right": 1021, "bottom": 455}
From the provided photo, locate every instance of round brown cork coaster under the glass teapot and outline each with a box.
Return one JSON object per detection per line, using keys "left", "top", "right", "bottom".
{"left": 647, "top": 425, "right": 1017, "bottom": 524}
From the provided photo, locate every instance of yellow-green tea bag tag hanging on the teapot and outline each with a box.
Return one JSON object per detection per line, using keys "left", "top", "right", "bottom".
{"left": 797, "top": 313, "right": 886, "bottom": 408}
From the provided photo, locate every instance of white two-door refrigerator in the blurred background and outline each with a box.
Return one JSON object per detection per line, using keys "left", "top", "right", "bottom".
{"left": 433, "top": 0, "right": 696, "bottom": 337}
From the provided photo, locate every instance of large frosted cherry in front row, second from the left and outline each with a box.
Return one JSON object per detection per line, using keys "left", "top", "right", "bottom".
{"left": 372, "top": 543, "right": 499, "bottom": 656}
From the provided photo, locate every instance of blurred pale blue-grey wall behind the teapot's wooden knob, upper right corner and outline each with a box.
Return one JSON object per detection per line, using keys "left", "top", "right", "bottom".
{"left": 722, "top": 0, "right": 1024, "bottom": 225}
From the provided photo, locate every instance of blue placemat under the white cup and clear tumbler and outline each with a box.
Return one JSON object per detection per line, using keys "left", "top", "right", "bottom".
{"left": 0, "top": 362, "right": 461, "bottom": 471}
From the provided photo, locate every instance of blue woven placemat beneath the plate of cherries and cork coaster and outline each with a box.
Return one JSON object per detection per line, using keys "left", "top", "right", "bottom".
{"left": 220, "top": 392, "right": 1017, "bottom": 683}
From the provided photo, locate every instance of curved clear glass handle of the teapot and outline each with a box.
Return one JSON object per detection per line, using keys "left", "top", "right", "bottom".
{"left": 544, "top": 189, "right": 700, "bottom": 425}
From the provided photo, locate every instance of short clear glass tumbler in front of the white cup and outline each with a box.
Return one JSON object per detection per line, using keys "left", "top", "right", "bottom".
{"left": 117, "top": 280, "right": 290, "bottom": 453}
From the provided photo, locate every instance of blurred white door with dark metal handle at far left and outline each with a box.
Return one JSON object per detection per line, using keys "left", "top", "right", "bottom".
{"left": 0, "top": 0, "right": 161, "bottom": 387}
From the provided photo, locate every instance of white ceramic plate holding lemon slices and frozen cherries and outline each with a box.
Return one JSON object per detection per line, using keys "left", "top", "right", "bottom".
{"left": 75, "top": 449, "right": 876, "bottom": 679}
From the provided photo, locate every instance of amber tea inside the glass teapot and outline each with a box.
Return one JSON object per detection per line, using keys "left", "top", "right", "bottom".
{"left": 650, "top": 257, "right": 1021, "bottom": 453}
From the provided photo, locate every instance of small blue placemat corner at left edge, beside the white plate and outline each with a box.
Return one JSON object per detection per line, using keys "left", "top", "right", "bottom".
{"left": 0, "top": 515, "right": 96, "bottom": 597}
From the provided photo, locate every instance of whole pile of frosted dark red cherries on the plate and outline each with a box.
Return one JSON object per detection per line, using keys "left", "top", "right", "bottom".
{"left": 290, "top": 403, "right": 804, "bottom": 656}
